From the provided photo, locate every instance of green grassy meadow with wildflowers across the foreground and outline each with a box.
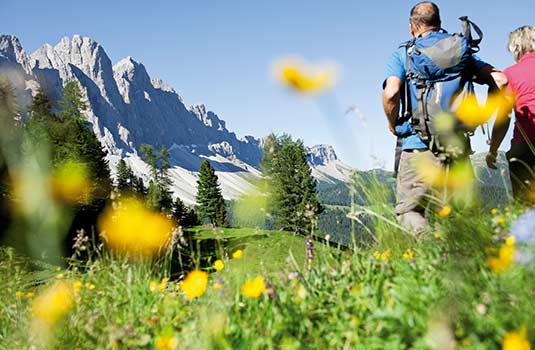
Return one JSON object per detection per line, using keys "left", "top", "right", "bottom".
{"left": 0, "top": 211, "right": 535, "bottom": 350}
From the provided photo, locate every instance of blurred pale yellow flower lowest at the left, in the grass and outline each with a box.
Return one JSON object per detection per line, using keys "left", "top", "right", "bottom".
{"left": 32, "top": 281, "right": 74, "bottom": 330}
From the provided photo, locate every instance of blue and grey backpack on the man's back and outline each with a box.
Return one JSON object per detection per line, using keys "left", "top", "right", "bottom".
{"left": 396, "top": 17, "right": 483, "bottom": 164}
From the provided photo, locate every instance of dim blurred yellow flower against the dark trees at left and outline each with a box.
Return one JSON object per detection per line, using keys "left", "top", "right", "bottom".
{"left": 50, "top": 161, "right": 92, "bottom": 203}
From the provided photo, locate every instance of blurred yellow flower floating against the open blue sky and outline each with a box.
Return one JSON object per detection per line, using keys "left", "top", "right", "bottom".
{"left": 274, "top": 58, "right": 336, "bottom": 95}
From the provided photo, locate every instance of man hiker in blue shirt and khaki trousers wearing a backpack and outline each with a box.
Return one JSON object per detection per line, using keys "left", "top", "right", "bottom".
{"left": 383, "top": 1, "right": 507, "bottom": 233}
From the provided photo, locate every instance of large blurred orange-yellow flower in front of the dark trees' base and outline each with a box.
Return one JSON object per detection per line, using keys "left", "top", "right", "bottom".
{"left": 99, "top": 198, "right": 173, "bottom": 256}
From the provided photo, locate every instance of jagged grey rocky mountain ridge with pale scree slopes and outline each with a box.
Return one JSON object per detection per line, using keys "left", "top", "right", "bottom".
{"left": 0, "top": 35, "right": 353, "bottom": 203}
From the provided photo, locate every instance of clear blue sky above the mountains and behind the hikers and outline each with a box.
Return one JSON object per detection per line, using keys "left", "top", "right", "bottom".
{"left": 0, "top": 0, "right": 535, "bottom": 169}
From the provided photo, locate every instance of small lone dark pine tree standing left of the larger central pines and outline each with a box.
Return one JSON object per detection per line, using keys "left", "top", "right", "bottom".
{"left": 197, "top": 160, "right": 227, "bottom": 227}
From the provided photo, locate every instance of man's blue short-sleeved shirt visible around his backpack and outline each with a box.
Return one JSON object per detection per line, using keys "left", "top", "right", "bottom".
{"left": 385, "top": 46, "right": 487, "bottom": 150}
